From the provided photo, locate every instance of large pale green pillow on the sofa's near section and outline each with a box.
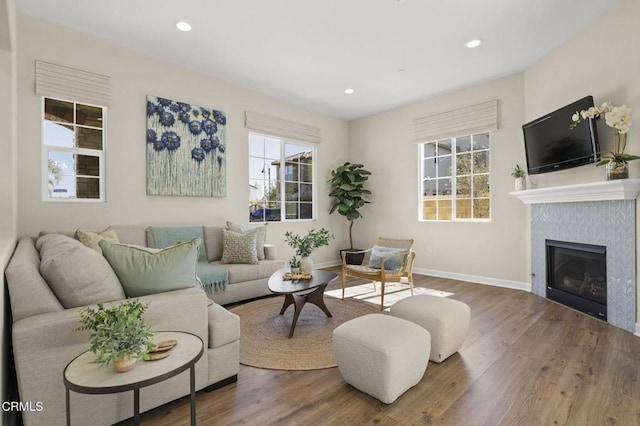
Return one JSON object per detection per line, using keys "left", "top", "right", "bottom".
{"left": 99, "top": 238, "right": 202, "bottom": 297}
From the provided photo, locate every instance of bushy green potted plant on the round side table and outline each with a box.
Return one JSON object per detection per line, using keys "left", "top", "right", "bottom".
{"left": 76, "top": 299, "right": 156, "bottom": 372}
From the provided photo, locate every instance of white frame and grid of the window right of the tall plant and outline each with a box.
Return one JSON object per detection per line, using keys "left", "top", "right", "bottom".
{"left": 418, "top": 132, "right": 493, "bottom": 223}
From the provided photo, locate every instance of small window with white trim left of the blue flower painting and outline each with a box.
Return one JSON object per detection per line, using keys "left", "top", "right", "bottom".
{"left": 42, "top": 97, "right": 106, "bottom": 201}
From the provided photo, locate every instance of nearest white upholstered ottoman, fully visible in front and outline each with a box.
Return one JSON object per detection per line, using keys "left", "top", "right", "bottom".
{"left": 333, "top": 314, "right": 431, "bottom": 404}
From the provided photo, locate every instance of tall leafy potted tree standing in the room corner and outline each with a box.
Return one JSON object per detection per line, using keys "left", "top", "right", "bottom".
{"left": 329, "top": 162, "right": 371, "bottom": 265}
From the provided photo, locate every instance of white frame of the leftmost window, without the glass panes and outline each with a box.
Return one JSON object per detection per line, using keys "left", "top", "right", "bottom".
{"left": 40, "top": 96, "right": 107, "bottom": 203}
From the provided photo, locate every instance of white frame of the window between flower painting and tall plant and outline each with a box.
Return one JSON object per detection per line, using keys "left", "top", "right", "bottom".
{"left": 247, "top": 131, "right": 318, "bottom": 223}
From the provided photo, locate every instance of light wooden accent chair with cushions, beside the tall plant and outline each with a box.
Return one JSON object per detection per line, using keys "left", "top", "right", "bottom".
{"left": 342, "top": 237, "right": 416, "bottom": 310}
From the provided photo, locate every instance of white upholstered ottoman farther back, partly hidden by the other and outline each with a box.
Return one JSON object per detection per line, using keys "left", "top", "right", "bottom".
{"left": 390, "top": 294, "right": 471, "bottom": 362}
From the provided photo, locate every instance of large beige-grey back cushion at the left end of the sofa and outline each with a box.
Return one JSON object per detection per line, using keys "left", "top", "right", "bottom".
{"left": 36, "top": 234, "right": 125, "bottom": 309}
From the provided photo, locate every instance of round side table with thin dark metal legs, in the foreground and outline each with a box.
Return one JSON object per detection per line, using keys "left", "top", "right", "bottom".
{"left": 63, "top": 331, "right": 203, "bottom": 425}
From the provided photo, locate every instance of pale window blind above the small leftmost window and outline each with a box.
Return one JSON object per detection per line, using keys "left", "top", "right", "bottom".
{"left": 36, "top": 61, "right": 111, "bottom": 106}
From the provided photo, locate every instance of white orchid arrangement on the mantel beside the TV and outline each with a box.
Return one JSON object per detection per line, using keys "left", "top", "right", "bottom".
{"left": 569, "top": 102, "right": 640, "bottom": 166}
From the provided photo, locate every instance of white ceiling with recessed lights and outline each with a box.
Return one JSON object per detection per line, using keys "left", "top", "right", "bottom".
{"left": 16, "top": 0, "right": 617, "bottom": 120}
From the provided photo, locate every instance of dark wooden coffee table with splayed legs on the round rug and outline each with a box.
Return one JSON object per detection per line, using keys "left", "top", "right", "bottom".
{"left": 269, "top": 268, "right": 338, "bottom": 338}
